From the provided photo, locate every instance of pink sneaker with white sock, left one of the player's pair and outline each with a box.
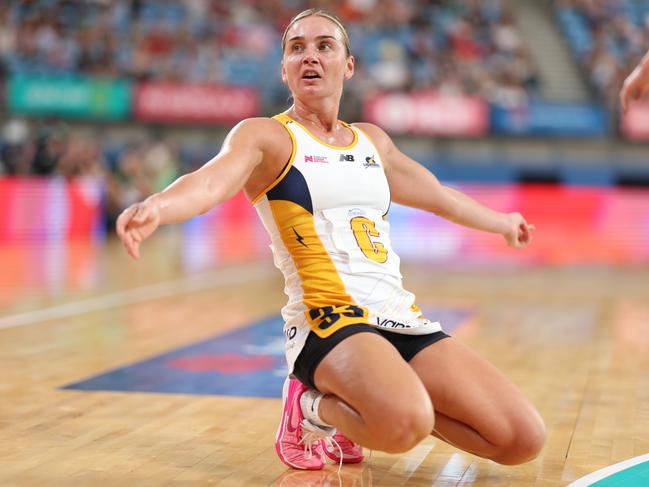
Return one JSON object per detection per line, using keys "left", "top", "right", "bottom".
{"left": 275, "top": 378, "right": 336, "bottom": 470}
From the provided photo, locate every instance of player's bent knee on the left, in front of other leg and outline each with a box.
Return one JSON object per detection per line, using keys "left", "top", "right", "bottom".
{"left": 370, "top": 399, "right": 435, "bottom": 453}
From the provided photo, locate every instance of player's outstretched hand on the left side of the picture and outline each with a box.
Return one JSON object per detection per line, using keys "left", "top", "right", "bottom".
{"left": 116, "top": 198, "right": 160, "bottom": 259}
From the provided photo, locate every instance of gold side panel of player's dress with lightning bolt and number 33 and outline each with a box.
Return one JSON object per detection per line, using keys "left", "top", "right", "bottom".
{"left": 269, "top": 200, "right": 368, "bottom": 338}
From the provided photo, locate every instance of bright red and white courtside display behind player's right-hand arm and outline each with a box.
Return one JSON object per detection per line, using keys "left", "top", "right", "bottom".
{"left": 388, "top": 184, "right": 649, "bottom": 267}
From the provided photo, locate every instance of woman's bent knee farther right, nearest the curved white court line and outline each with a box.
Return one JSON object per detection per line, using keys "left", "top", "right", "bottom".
{"left": 493, "top": 416, "right": 546, "bottom": 465}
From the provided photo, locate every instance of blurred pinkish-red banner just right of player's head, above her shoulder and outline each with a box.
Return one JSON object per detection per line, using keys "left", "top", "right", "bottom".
{"left": 364, "top": 91, "right": 489, "bottom": 137}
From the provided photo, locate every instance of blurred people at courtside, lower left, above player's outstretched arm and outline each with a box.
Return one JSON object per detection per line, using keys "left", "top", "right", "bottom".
{"left": 0, "top": 119, "right": 195, "bottom": 227}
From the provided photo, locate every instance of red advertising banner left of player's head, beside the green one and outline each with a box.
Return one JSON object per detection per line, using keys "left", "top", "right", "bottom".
{"left": 133, "top": 82, "right": 261, "bottom": 123}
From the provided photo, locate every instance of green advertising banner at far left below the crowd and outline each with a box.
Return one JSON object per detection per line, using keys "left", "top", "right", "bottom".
{"left": 6, "top": 76, "right": 132, "bottom": 120}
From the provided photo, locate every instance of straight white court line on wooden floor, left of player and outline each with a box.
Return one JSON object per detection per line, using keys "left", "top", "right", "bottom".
{"left": 0, "top": 263, "right": 277, "bottom": 330}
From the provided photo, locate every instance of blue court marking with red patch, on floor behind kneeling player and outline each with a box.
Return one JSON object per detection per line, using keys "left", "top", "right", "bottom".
{"left": 63, "top": 308, "right": 473, "bottom": 397}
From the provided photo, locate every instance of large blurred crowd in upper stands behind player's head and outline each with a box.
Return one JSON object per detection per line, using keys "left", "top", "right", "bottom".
{"left": 0, "top": 0, "right": 538, "bottom": 110}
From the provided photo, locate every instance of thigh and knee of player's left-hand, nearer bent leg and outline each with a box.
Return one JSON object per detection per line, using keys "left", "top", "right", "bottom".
{"left": 314, "top": 333, "right": 435, "bottom": 453}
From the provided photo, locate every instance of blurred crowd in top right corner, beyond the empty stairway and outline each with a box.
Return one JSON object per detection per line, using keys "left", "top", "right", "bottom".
{"left": 556, "top": 0, "right": 649, "bottom": 107}
